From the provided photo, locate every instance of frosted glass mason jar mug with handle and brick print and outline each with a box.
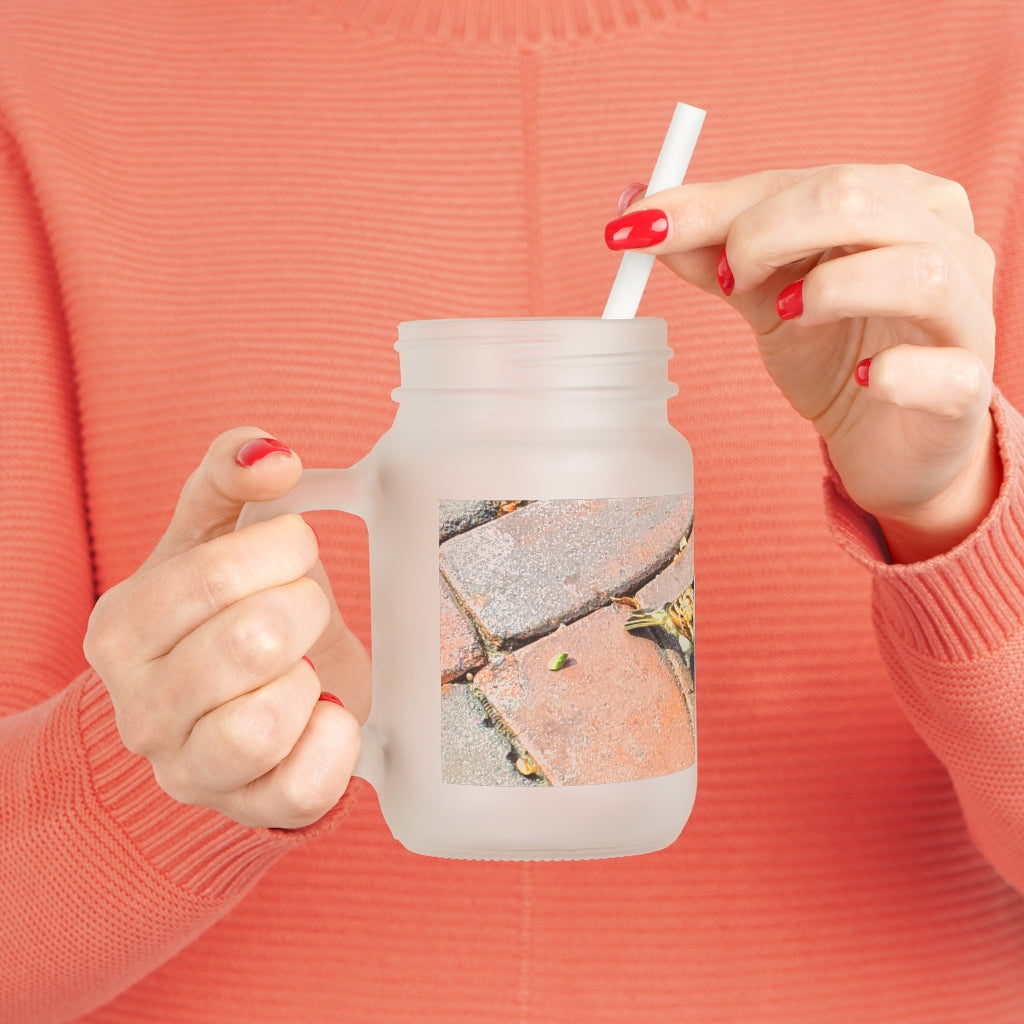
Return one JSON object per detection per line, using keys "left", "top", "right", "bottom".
{"left": 240, "top": 318, "right": 696, "bottom": 860}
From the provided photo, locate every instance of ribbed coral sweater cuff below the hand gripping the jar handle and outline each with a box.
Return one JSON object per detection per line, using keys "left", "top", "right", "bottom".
{"left": 78, "top": 672, "right": 350, "bottom": 902}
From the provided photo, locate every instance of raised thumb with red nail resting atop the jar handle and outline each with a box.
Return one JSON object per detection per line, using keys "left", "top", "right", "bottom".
{"left": 145, "top": 427, "right": 302, "bottom": 565}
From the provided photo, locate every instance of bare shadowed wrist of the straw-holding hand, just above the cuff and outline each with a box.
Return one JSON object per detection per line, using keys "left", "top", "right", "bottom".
{"left": 874, "top": 415, "right": 1002, "bottom": 564}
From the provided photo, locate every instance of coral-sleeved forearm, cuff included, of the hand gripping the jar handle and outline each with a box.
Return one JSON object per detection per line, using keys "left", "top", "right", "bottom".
{"left": 0, "top": 672, "right": 344, "bottom": 1024}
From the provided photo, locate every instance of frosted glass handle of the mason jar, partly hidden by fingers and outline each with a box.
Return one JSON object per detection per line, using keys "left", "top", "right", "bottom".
{"left": 234, "top": 463, "right": 385, "bottom": 793}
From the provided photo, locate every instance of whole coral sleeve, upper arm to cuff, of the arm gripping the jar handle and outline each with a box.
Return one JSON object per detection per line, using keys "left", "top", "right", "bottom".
{"left": 0, "top": 133, "right": 345, "bottom": 1024}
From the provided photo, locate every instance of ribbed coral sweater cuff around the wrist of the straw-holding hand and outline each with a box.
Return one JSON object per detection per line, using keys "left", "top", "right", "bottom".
{"left": 825, "top": 392, "right": 1024, "bottom": 660}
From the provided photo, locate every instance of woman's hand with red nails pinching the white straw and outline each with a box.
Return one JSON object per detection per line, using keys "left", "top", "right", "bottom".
{"left": 606, "top": 166, "right": 1001, "bottom": 562}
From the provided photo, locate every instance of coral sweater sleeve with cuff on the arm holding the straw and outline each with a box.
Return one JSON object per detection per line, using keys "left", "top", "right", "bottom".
{"left": 825, "top": 393, "right": 1024, "bottom": 892}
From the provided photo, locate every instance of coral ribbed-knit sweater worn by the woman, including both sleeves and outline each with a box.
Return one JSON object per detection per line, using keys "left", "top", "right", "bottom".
{"left": 0, "top": 0, "right": 1024, "bottom": 1024}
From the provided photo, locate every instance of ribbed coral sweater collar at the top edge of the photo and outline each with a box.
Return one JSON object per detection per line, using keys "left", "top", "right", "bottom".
{"left": 318, "top": 0, "right": 707, "bottom": 45}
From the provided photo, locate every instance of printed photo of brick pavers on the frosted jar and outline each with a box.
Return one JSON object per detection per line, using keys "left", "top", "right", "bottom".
{"left": 439, "top": 495, "right": 694, "bottom": 785}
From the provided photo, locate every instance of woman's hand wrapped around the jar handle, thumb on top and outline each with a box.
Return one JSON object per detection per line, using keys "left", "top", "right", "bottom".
{"left": 85, "top": 427, "right": 370, "bottom": 828}
